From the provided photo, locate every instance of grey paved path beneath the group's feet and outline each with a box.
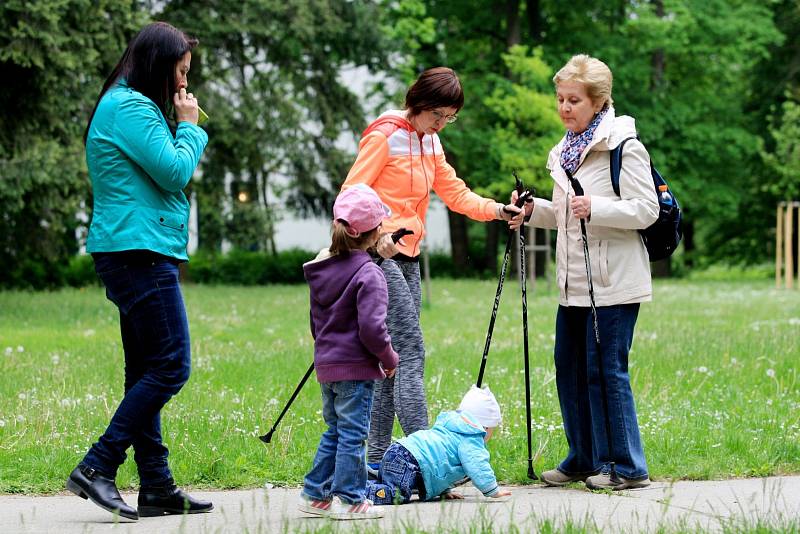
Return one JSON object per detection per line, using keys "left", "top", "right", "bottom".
{"left": 0, "top": 477, "right": 800, "bottom": 534}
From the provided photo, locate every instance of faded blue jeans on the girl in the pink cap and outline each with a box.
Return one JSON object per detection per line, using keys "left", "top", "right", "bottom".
{"left": 303, "top": 380, "right": 375, "bottom": 504}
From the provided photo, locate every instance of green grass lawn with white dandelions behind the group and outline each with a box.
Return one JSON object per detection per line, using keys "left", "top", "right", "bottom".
{"left": 0, "top": 280, "right": 800, "bottom": 493}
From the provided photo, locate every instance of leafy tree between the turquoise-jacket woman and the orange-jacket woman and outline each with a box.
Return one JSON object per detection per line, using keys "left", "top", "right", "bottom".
{"left": 161, "top": 0, "right": 386, "bottom": 250}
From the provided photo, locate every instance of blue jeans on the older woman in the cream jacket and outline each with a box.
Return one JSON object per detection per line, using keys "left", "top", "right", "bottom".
{"left": 555, "top": 304, "right": 647, "bottom": 480}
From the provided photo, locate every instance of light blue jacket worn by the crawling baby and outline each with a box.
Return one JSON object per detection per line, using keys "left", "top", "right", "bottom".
{"left": 399, "top": 411, "right": 500, "bottom": 500}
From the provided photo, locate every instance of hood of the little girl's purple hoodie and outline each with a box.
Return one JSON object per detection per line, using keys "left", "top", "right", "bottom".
{"left": 303, "top": 249, "right": 372, "bottom": 307}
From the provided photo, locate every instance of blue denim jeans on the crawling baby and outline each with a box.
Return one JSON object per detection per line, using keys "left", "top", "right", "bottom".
{"left": 367, "top": 443, "right": 425, "bottom": 504}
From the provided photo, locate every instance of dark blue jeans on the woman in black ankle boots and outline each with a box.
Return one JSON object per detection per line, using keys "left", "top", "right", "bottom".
{"left": 83, "top": 254, "right": 191, "bottom": 487}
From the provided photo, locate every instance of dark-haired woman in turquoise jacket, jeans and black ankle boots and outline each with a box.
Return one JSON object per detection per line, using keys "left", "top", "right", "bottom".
{"left": 67, "top": 22, "right": 213, "bottom": 519}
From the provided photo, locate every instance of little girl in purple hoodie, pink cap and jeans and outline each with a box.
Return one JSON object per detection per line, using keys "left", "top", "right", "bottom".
{"left": 300, "top": 184, "right": 398, "bottom": 519}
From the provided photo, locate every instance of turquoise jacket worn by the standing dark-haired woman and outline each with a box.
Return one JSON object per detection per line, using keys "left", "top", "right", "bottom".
{"left": 86, "top": 80, "right": 208, "bottom": 260}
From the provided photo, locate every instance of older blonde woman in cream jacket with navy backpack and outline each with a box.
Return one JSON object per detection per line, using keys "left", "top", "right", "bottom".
{"left": 514, "top": 55, "right": 658, "bottom": 490}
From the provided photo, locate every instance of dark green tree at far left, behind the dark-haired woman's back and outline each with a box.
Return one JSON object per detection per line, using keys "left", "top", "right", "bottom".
{"left": 0, "top": 0, "right": 144, "bottom": 286}
